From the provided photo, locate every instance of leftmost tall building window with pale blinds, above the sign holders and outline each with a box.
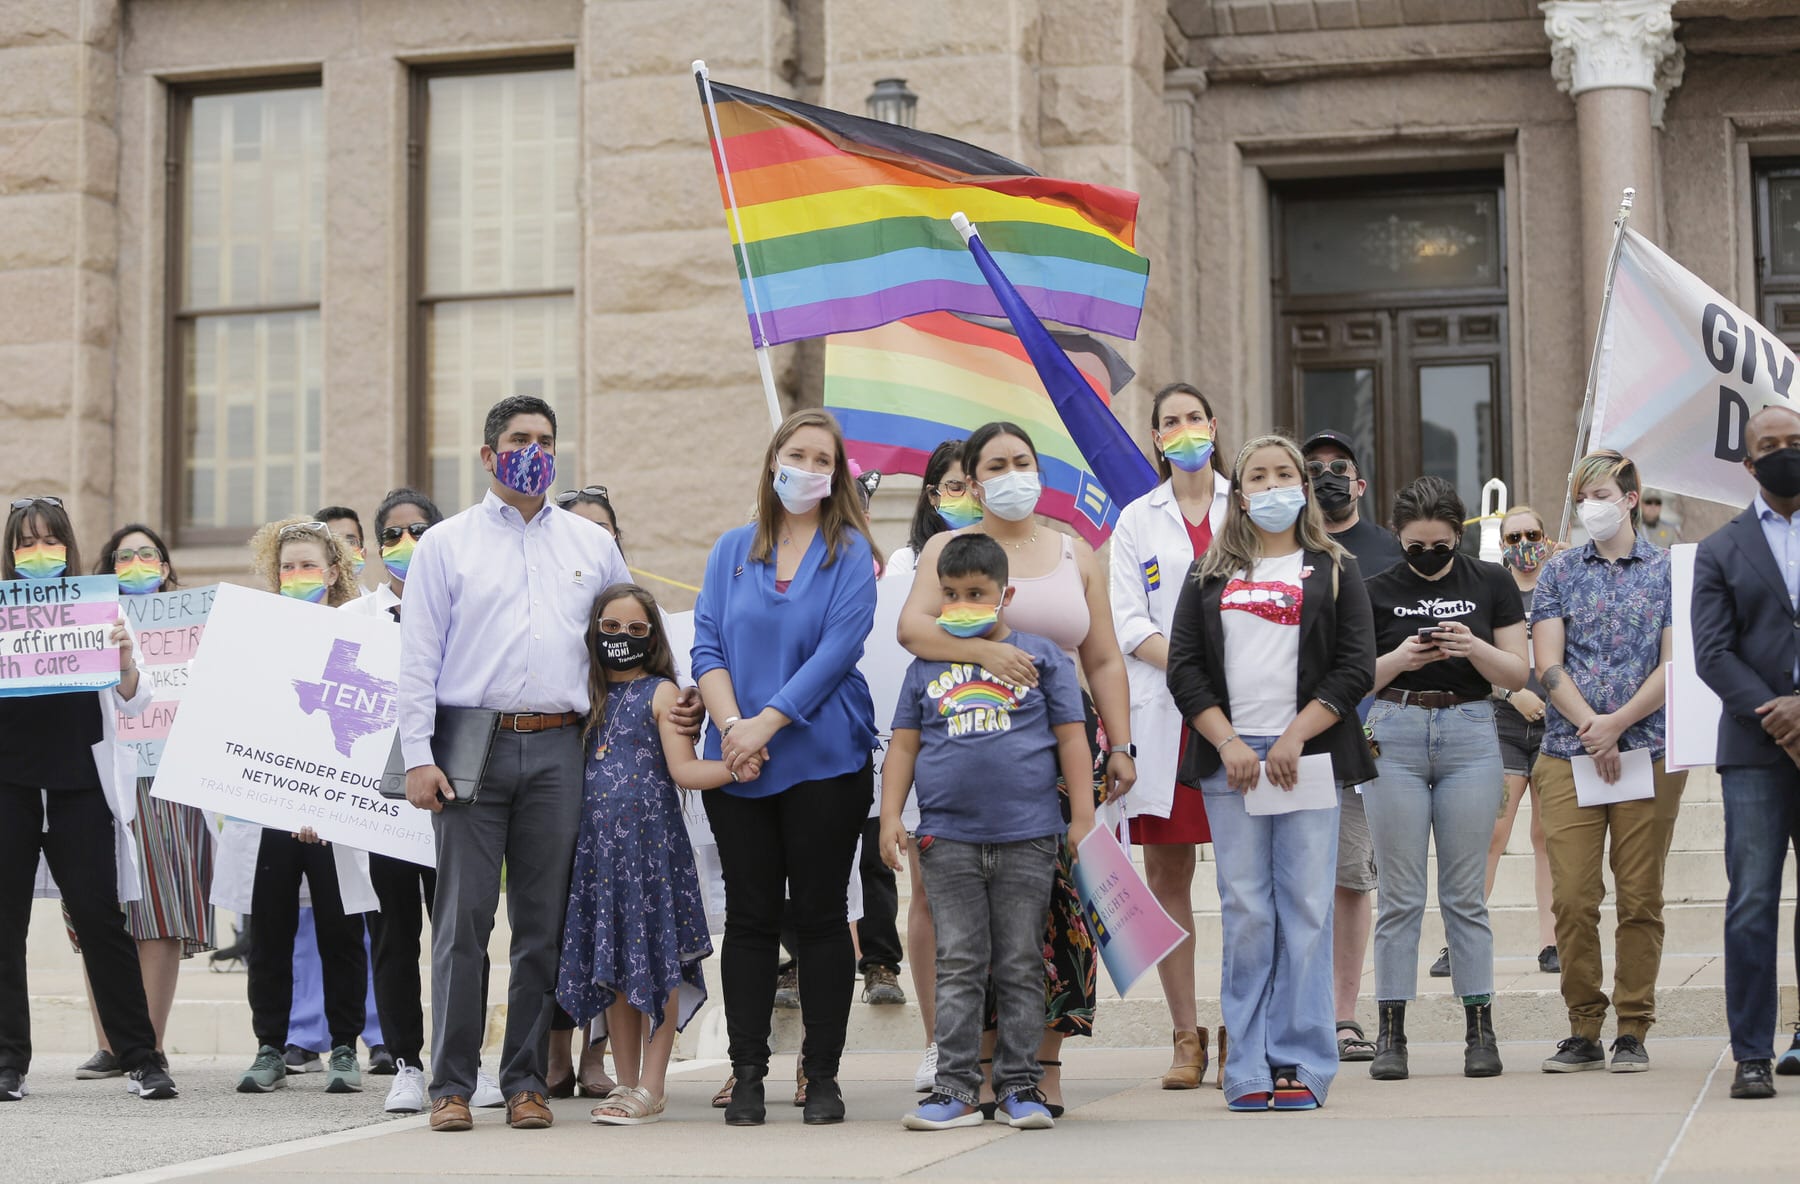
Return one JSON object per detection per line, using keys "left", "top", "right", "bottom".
{"left": 169, "top": 81, "right": 324, "bottom": 543}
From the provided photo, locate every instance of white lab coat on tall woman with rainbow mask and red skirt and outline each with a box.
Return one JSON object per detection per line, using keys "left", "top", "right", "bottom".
{"left": 1107, "top": 475, "right": 1231, "bottom": 819}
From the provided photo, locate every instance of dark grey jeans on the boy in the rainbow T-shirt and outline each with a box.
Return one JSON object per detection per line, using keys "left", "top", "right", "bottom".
{"left": 918, "top": 835, "right": 1062, "bottom": 1105}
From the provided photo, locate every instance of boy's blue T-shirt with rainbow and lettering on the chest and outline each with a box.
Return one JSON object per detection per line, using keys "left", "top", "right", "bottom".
{"left": 895, "top": 630, "right": 1087, "bottom": 842}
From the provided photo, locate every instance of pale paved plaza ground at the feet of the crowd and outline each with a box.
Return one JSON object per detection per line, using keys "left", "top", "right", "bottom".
{"left": 0, "top": 1038, "right": 1800, "bottom": 1184}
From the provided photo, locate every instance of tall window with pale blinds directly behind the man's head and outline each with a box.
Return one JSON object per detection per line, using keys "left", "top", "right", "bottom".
{"left": 412, "top": 61, "right": 581, "bottom": 509}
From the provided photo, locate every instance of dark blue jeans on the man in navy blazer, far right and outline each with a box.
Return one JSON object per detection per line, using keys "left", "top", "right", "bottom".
{"left": 1719, "top": 758, "right": 1800, "bottom": 1062}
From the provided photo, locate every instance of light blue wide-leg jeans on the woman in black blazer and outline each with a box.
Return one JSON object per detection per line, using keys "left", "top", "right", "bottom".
{"left": 1209, "top": 736, "right": 1337, "bottom": 1101}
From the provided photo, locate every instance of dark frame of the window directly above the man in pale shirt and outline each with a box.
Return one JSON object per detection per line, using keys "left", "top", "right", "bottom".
{"left": 405, "top": 50, "right": 583, "bottom": 497}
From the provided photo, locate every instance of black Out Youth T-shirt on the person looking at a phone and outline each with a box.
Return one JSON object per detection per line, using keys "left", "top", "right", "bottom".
{"left": 1368, "top": 554, "right": 1525, "bottom": 698}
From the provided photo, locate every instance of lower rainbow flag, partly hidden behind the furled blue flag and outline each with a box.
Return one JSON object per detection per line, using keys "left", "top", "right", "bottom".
{"left": 824, "top": 305, "right": 1132, "bottom": 547}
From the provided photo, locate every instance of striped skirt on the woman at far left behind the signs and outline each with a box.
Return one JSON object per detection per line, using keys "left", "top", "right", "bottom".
{"left": 63, "top": 777, "right": 218, "bottom": 957}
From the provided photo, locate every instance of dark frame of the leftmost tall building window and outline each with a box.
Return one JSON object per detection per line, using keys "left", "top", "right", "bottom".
{"left": 162, "top": 70, "right": 329, "bottom": 547}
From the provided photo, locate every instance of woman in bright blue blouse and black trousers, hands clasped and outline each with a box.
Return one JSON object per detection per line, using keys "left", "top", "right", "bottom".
{"left": 693, "top": 410, "right": 878, "bottom": 1126}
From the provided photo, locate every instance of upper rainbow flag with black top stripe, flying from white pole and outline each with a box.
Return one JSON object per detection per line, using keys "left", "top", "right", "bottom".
{"left": 700, "top": 77, "right": 1150, "bottom": 345}
